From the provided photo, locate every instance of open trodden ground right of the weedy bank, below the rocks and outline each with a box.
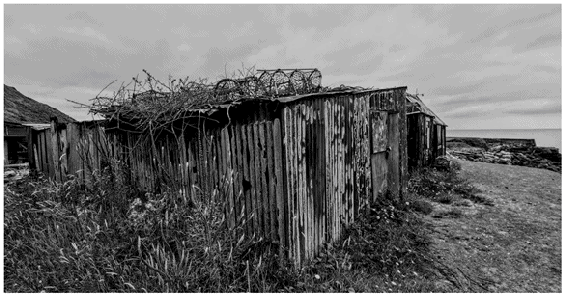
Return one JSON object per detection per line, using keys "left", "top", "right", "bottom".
{"left": 425, "top": 161, "right": 562, "bottom": 292}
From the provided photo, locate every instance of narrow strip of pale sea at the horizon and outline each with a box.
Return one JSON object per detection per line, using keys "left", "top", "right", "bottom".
{"left": 446, "top": 129, "right": 562, "bottom": 153}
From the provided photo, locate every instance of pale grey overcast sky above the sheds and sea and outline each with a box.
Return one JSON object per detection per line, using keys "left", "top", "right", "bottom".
{"left": 4, "top": 5, "right": 562, "bottom": 129}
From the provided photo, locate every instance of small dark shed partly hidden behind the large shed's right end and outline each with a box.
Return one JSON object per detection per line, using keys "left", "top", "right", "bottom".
{"left": 406, "top": 93, "right": 447, "bottom": 168}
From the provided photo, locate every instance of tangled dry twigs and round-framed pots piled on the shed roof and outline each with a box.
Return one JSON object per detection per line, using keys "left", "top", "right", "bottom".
{"left": 89, "top": 69, "right": 323, "bottom": 130}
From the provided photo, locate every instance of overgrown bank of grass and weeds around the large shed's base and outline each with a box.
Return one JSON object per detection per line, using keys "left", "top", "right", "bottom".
{"left": 4, "top": 165, "right": 480, "bottom": 292}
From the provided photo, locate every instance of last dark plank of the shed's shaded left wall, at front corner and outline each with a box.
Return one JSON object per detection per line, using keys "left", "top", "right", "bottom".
{"left": 273, "top": 118, "right": 289, "bottom": 263}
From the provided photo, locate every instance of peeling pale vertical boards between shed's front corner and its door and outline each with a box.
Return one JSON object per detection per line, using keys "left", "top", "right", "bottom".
{"left": 283, "top": 95, "right": 380, "bottom": 264}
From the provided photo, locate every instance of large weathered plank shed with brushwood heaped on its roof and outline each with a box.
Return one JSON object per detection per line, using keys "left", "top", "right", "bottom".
{"left": 34, "top": 81, "right": 407, "bottom": 264}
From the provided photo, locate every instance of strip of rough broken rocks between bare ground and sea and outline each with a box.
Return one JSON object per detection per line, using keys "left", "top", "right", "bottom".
{"left": 446, "top": 138, "right": 562, "bottom": 172}
